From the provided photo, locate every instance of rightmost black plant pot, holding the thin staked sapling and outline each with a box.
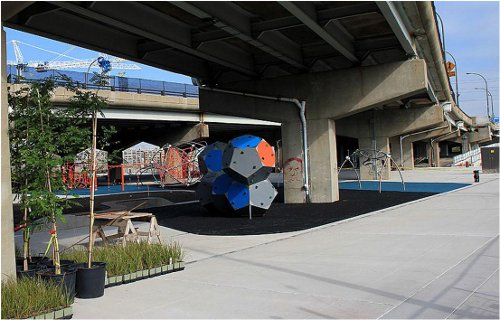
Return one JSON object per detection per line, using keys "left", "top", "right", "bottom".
{"left": 76, "top": 262, "right": 106, "bottom": 299}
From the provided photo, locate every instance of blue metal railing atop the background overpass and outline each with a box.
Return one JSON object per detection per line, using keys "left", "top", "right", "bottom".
{"left": 7, "top": 65, "right": 198, "bottom": 98}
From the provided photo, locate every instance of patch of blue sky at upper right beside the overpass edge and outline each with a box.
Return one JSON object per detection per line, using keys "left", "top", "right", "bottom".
{"left": 434, "top": 1, "right": 500, "bottom": 116}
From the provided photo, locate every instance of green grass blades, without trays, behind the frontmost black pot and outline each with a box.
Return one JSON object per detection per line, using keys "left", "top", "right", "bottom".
{"left": 61, "top": 241, "right": 184, "bottom": 277}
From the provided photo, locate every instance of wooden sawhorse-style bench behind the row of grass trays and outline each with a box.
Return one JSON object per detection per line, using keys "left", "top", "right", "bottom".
{"left": 92, "top": 211, "right": 161, "bottom": 246}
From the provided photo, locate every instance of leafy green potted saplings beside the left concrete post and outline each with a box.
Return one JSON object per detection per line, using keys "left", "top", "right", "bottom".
{"left": 9, "top": 76, "right": 114, "bottom": 274}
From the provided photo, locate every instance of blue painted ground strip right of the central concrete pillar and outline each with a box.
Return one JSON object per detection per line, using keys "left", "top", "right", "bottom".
{"left": 339, "top": 181, "right": 470, "bottom": 193}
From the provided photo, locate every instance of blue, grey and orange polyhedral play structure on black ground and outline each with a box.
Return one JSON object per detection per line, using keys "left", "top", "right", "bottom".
{"left": 196, "top": 135, "right": 278, "bottom": 217}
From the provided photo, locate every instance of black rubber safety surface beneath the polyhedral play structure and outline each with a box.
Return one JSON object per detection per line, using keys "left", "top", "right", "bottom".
{"left": 144, "top": 190, "right": 435, "bottom": 236}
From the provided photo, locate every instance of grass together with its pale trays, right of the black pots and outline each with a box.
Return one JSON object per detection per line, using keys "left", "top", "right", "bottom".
{"left": 62, "top": 242, "right": 184, "bottom": 287}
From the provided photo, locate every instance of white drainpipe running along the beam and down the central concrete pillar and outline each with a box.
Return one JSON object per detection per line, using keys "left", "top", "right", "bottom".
{"left": 199, "top": 87, "right": 311, "bottom": 203}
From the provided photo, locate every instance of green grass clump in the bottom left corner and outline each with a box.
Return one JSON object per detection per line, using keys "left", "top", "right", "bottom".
{"left": 2, "top": 277, "right": 71, "bottom": 319}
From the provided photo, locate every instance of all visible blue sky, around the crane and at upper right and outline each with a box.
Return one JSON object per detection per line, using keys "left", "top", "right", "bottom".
{"left": 5, "top": 1, "right": 500, "bottom": 116}
